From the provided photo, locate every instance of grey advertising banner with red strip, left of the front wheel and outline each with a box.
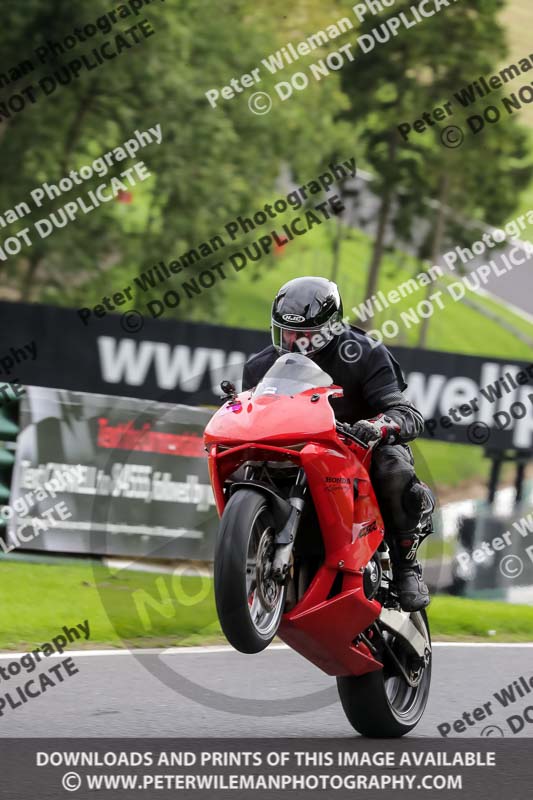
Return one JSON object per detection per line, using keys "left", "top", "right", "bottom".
{"left": 4, "top": 386, "right": 217, "bottom": 560}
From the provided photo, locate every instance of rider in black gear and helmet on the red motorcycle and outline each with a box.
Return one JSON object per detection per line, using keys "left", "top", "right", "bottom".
{"left": 243, "top": 277, "right": 434, "bottom": 611}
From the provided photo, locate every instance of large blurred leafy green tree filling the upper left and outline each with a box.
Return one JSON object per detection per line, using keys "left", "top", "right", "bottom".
{"left": 0, "top": 0, "right": 354, "bottom": 316}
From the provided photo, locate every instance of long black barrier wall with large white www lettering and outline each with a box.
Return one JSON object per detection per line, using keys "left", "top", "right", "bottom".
{"left": 0, "top": 302, "right": 533, "bottom": 450}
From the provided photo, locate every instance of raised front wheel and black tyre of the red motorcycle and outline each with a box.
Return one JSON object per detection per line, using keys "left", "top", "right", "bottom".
{"left": 214, "top": 489, "right": 287, "bottom": 653}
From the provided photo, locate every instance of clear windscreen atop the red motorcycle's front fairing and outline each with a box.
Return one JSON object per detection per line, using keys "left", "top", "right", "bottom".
{"left": 254, "top": 353, "right": 333, "bottom": 397}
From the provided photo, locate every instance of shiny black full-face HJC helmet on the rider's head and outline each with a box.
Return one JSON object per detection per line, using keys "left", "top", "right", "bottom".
{"left": 272, "top": 277, "right": 342, "bottom": 356}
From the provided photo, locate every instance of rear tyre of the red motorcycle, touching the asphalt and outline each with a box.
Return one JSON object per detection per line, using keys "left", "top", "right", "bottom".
{"left": 337, "top": 610, "right": 431, "bottom": 739}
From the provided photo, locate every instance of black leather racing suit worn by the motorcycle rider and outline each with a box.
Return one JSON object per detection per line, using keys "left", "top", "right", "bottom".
{"left": 243, "top": 326, "right": 430, "bottom": 544}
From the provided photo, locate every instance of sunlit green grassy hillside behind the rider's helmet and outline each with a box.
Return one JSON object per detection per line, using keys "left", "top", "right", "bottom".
{"left": 215, "top": 223, "right": 533, "bottom": 360}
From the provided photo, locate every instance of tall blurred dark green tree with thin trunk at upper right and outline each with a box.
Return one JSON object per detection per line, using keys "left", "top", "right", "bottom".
{"left": 336, "top": 0, "right": 529, "bottom": 310}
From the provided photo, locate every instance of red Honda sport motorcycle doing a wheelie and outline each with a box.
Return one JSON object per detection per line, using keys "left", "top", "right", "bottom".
{"left": 204, "top": 354, "right": 431, "bottom": 737}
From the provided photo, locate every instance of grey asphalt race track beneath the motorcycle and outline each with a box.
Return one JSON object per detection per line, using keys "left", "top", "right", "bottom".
{"left": 0, "top": 643, "right": 533, "bottom": 737}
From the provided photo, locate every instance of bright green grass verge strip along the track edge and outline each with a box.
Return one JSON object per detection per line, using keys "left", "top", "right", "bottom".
{"left": 0, "top": 558, "right": 533, "bottom": 651}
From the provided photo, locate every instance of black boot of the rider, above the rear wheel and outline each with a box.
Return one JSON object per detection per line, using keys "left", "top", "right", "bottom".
{"left": 389, "top": 533, "right": 430, "bottom": 611}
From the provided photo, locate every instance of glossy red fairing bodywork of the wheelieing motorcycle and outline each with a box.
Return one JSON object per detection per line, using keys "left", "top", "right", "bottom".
{"left": 204, "top": 386, "right": 384, "bottom": 675}
